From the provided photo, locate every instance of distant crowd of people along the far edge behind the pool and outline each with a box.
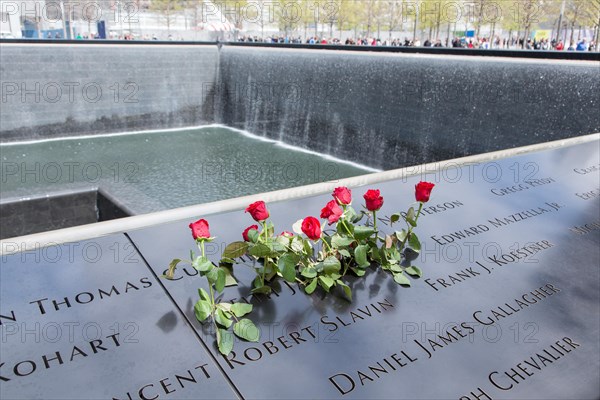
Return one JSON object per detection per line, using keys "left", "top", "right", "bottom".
{"left": 238, "top": 36, "right": 597, "bottom": 51}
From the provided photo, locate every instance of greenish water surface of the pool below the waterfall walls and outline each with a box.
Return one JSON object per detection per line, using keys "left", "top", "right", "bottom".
{"left": 0, "top": 126, "right": 375, "bottom": 214}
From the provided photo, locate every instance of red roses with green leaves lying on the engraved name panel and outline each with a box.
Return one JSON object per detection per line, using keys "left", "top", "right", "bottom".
{"left": 164, "top": 182, "right": 435, "bottom": 355}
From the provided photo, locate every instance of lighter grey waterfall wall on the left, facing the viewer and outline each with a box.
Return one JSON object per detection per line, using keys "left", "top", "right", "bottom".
{"left": 0, "top": 43, "right": 219, "bottom": 142}
